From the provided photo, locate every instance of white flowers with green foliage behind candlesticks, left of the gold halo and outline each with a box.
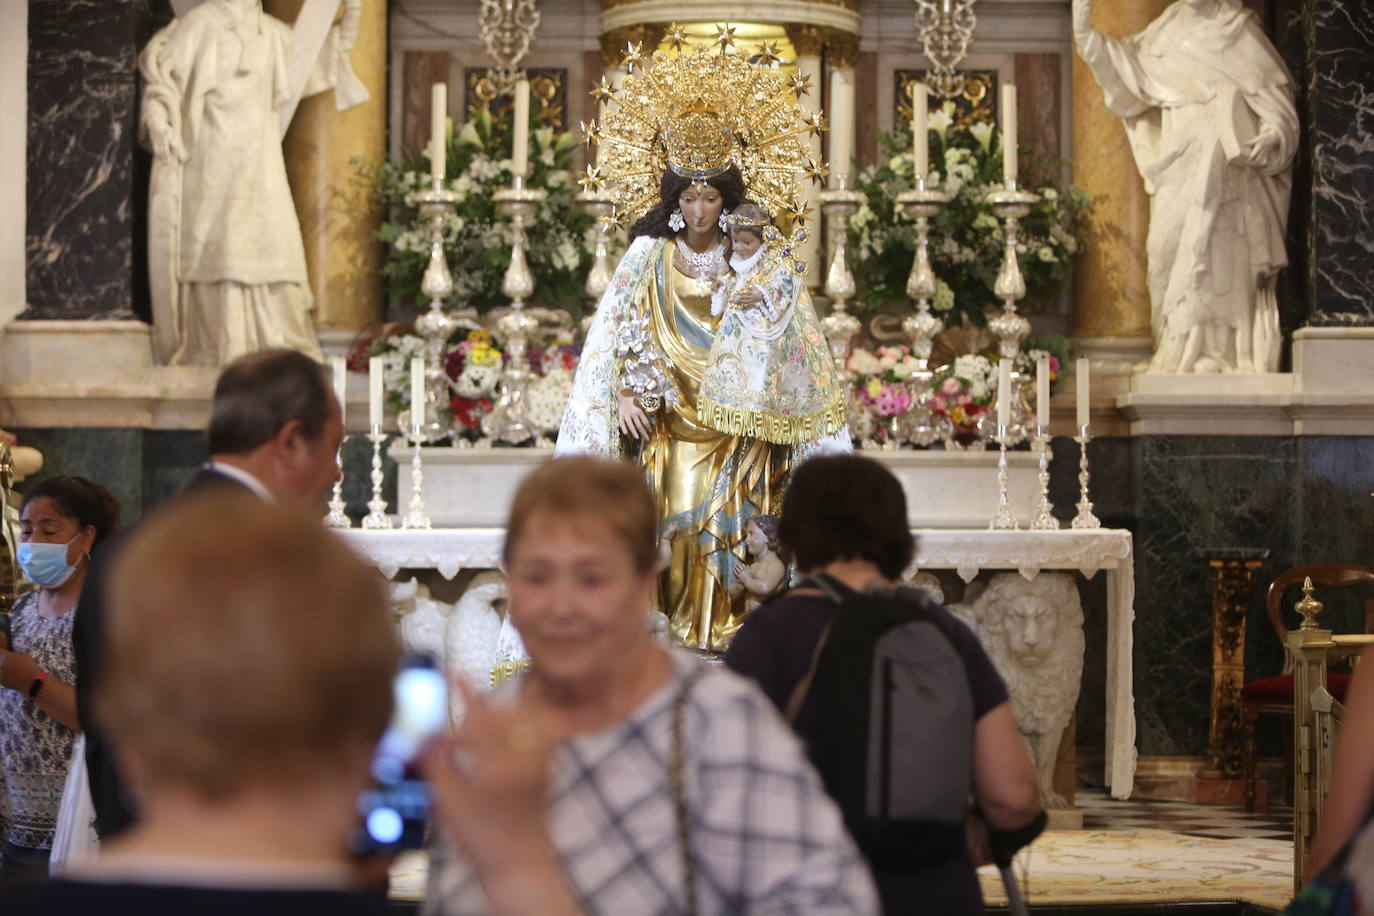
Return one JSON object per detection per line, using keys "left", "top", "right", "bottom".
{"left": 359, "top": 108, "right": 594, "bottom": 312}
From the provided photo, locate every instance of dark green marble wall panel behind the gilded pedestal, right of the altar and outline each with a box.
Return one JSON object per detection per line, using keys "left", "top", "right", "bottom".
{"left": 1132, "top": 437, "right": 1297, "bottom": 755}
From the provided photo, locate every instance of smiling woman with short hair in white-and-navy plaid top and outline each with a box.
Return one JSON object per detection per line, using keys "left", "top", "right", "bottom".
{"left": 426, "top": 457, "right": 877, "bottom": 916}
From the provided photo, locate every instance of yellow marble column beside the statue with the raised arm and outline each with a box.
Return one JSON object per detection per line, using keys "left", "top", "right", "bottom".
{"left": 1073, "top": 0, "right": 1171, "bottom": 358}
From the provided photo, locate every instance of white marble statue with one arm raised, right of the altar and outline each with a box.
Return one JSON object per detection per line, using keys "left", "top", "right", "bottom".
{"left": 1073, "top": 0, "right": 1298, "bottom": 372}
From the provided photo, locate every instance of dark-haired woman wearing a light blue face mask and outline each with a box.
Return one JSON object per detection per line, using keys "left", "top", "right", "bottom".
{"left": 0, "top": 477, "right": 120, "bottom": 889}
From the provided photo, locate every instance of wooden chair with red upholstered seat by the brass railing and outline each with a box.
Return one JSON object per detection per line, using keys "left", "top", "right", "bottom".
{"left": 1241, "top": 563, "right": 1374, "bottom": 812}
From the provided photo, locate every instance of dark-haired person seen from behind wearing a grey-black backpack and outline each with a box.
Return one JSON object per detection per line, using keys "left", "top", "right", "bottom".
{"left": 725, "top": 456, "right": 1044, "bottom": 916}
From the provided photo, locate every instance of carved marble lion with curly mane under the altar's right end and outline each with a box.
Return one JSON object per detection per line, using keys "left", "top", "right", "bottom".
{"left": 949, "top": 573, "right": 1083, "bottom": 808}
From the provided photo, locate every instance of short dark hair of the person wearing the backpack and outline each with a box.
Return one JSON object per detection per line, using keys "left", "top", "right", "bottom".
{"left": 778, "top": 455, "right": 916, "bottom": 580}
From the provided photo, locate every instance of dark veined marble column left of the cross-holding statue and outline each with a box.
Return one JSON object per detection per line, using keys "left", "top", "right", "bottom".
{"left": 19, "top": 0, "right": 168, "bottom": 319}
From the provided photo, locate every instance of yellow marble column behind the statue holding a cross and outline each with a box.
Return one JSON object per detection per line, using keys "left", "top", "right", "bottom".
{"left": 264, "top": 0, "right": 386, "bottom": 336}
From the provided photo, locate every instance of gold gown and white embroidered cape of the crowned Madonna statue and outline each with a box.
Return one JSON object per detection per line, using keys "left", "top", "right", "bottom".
{"left": 555, "top": 238, "right": 797, "bottom": 651}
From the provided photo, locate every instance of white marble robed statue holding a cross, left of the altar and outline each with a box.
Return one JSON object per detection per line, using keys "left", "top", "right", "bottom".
{"left": 139, "top": 0, "right": 367, "bottom": 365}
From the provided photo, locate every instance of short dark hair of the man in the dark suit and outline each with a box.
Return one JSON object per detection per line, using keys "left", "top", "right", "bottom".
{"left": 206, "top": 349, "right": 331, "bottom": 455}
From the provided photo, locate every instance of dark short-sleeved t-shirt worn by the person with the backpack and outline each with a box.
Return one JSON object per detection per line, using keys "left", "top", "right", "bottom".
{"left": 725, "top": 593, "right": 1009, "bottom": 916}
